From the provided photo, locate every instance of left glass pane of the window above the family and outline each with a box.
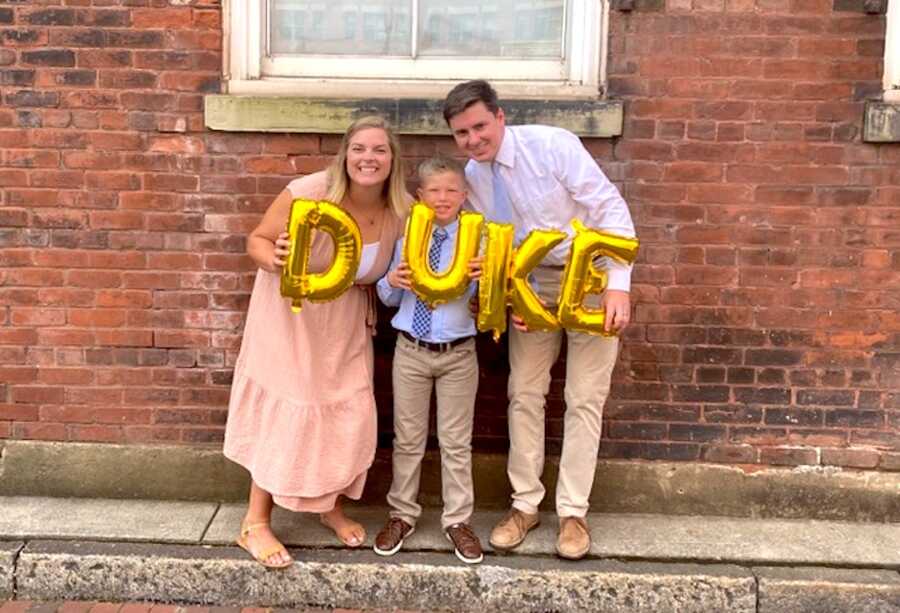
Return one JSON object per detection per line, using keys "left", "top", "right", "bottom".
{"left": 269, "top": 0, "right": 412, "bottom": 56}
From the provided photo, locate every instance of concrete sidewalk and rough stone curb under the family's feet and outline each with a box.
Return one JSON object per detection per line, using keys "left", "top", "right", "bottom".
{"left": 0, "top": 497, "right": 900, "bottom": 613}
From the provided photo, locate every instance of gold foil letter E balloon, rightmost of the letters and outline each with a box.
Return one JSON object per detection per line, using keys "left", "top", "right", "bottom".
{"left": 557, "top": 219, "right": 638, "bottom": 336}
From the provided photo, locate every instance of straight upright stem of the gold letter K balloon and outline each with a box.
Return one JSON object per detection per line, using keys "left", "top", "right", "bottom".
{"left": 477, "top": 222, "right": 515, "bottom": 342}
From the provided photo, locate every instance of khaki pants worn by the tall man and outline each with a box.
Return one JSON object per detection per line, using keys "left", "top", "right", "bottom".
{"left": 507, "top": 268, "right": 619, "bottom": 517}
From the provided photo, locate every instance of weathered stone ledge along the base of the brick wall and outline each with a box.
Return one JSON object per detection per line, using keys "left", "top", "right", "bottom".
{"left": 0, "top": 441, "right": 900, "bottom": 522}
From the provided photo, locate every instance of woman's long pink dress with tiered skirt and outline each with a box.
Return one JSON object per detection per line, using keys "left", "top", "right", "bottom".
{"left": 224, "top": 173, "right": 401, "bottom": 513}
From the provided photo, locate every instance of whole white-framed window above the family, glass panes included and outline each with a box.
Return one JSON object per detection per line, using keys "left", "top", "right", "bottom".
{"left": 226, "top": 0, "right": 608, "bottom": 96}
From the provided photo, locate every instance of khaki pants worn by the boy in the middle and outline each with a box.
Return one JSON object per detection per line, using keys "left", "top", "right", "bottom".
{"left": 387, "top": 336, "right": 478, "bottom": 528}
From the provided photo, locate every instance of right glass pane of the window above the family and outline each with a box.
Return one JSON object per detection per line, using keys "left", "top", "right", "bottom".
{"left": 419, "top": 0, "right": 564, "bottom": 58}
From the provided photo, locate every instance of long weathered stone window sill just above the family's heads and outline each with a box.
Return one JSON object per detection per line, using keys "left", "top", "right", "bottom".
{"left": 204, "top": 94, "right": 624, "bottom": 138}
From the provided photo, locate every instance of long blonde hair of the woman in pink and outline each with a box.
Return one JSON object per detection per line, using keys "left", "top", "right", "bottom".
{"left": 326, "top": 115, "right": 410, "bottom": 219}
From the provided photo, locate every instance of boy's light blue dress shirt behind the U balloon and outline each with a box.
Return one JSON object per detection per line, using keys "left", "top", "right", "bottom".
{"left": 375, "top": 218, "right": 477, "bottom": 343}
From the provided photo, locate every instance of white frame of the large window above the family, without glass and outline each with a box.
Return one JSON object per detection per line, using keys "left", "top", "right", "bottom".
{"left": 224, "top": 0, "right": 609, "bottom": 98}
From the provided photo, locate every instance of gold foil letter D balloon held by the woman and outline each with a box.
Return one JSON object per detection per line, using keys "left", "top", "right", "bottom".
{"left": 281, "top": 200, "right": 362, "bottom": 313}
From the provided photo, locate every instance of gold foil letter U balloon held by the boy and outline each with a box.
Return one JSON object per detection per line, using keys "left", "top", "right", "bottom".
{"left": 403, "top": 202, "right": 484, "bottom": 309}
